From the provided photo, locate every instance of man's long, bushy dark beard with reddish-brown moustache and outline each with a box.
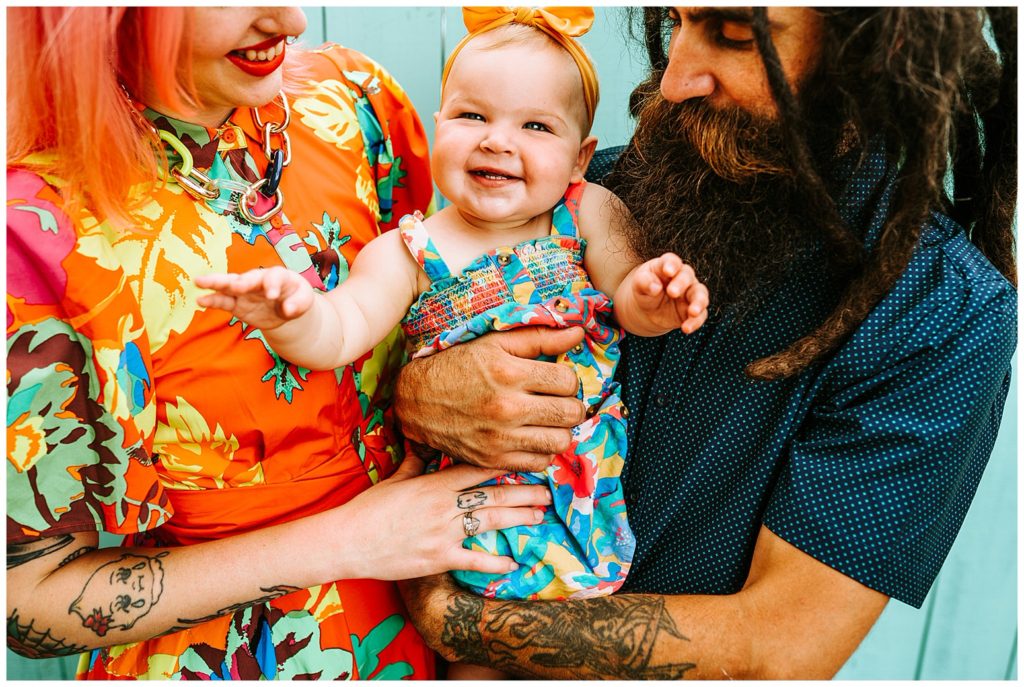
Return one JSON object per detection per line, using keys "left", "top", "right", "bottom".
{"left": 605, "top": 84, "right": 813, "bottom": 312}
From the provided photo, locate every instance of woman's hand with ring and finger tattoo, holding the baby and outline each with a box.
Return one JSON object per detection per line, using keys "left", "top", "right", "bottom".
{"left": 325, "top": 455, "right": 551, "bottom": 579}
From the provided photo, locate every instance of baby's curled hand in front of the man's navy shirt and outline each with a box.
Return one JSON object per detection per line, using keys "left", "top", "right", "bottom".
{"left": 633, "top": 253, "right": 708, "bottom": 334}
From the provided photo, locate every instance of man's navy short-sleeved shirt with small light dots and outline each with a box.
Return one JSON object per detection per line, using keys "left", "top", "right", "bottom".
{"left": 618, "top": 145, "right": 1017, "bottom": 607}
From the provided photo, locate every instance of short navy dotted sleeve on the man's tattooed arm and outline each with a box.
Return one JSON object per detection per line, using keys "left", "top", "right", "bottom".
{"left": 764, "top": 268, "right": 1017, "bottom": 607}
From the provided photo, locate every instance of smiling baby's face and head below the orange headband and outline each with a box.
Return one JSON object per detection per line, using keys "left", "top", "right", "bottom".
{"left": 431, "top": 34, "right": 596, "bottom": 222}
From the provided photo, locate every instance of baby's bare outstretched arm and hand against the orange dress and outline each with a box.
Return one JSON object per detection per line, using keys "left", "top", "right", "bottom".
{"left": 196, "top": 231, "right": 418, "bottom": 370}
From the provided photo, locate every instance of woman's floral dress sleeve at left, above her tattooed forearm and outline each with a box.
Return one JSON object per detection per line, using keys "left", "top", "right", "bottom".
{"left": 7, "top": 170, "right": 171, "bottom": 543}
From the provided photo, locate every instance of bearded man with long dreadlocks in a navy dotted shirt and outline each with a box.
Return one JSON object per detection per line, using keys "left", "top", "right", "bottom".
{"left": 396, "top": 7, "right": 1017, "bottom": 679}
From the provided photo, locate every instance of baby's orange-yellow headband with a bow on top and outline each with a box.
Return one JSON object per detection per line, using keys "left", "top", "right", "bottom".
{"left": 441, "top": 7, "right": 598, "bottom": 128}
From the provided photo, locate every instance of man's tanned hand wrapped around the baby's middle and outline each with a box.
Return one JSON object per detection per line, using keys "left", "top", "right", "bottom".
{"left": 395, "top": 327, "right": 586, "bottom": 472}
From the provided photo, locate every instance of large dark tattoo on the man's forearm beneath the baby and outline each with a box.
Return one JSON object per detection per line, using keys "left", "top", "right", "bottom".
{"left": 441, "top": 594, "right": 696, "bottom": 680}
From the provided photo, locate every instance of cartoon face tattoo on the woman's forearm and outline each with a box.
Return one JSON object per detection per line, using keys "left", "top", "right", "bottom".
{"left": 68, "top": 551, "right": 168, "bottom": 637}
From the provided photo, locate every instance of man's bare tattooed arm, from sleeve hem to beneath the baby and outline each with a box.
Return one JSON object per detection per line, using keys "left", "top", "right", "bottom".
{"left": 401, "top": 527, "right": 888, "bottom": 680}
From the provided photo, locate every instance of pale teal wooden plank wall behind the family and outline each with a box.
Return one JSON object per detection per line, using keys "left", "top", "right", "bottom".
{"left": 6, "top": 7, "right": 1017, "bottom": 680}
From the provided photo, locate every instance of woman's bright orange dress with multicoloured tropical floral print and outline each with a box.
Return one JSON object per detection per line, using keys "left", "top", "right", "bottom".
{"left": 7, "top": 46, "right": 434, "bottom": 680}
